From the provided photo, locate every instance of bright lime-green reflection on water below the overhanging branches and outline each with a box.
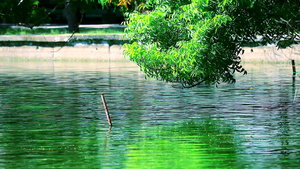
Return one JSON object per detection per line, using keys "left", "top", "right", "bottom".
{"left": 126, "top": 119, "right": 238, "bottom": 168}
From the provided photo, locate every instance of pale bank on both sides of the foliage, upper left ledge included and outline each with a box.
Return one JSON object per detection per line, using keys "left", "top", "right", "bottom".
{"left": 0, "top": 34, "right": 300, "bottom": 63}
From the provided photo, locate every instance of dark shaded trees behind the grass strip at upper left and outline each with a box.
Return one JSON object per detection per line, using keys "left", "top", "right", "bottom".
{"left": 0, "top": 0, "right": 124, "bottom": 32}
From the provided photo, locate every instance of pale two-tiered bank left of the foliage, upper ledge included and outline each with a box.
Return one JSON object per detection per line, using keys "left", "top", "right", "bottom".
{"left": 0, "top": 34, "right": 126, "bottom": 61}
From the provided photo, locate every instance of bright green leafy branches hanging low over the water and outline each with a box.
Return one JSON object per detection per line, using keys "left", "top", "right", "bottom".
{"left": 124, "top": 0, "right": 300, "bottom": 87}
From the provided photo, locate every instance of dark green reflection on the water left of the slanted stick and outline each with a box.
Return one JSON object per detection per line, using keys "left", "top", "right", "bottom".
{"left": 0, "top": 73, "right": 116, "bottom": 168}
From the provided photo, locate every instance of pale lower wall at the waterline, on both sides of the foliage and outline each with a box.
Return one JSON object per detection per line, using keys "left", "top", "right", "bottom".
{"left": 0, "top": 41, "right": 300, "bottom": 63}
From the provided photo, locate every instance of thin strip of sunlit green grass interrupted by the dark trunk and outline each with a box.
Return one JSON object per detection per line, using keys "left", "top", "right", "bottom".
{"left": 0, "top": 28, "right": 124, "bottom": 35}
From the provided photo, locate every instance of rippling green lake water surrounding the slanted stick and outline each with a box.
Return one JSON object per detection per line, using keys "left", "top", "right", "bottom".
{"left": 0, "top": 61, "right": 300, "bottom": 169}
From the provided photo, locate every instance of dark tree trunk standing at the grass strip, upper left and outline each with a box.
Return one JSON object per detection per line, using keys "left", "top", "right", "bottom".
{"left": 65, "top": 0, "right": 80, "bottom": 33}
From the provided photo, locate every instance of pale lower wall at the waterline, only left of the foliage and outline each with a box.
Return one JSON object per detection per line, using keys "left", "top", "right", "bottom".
{"left": 0, "top": 44, "right": 126, "bottom": 61}
